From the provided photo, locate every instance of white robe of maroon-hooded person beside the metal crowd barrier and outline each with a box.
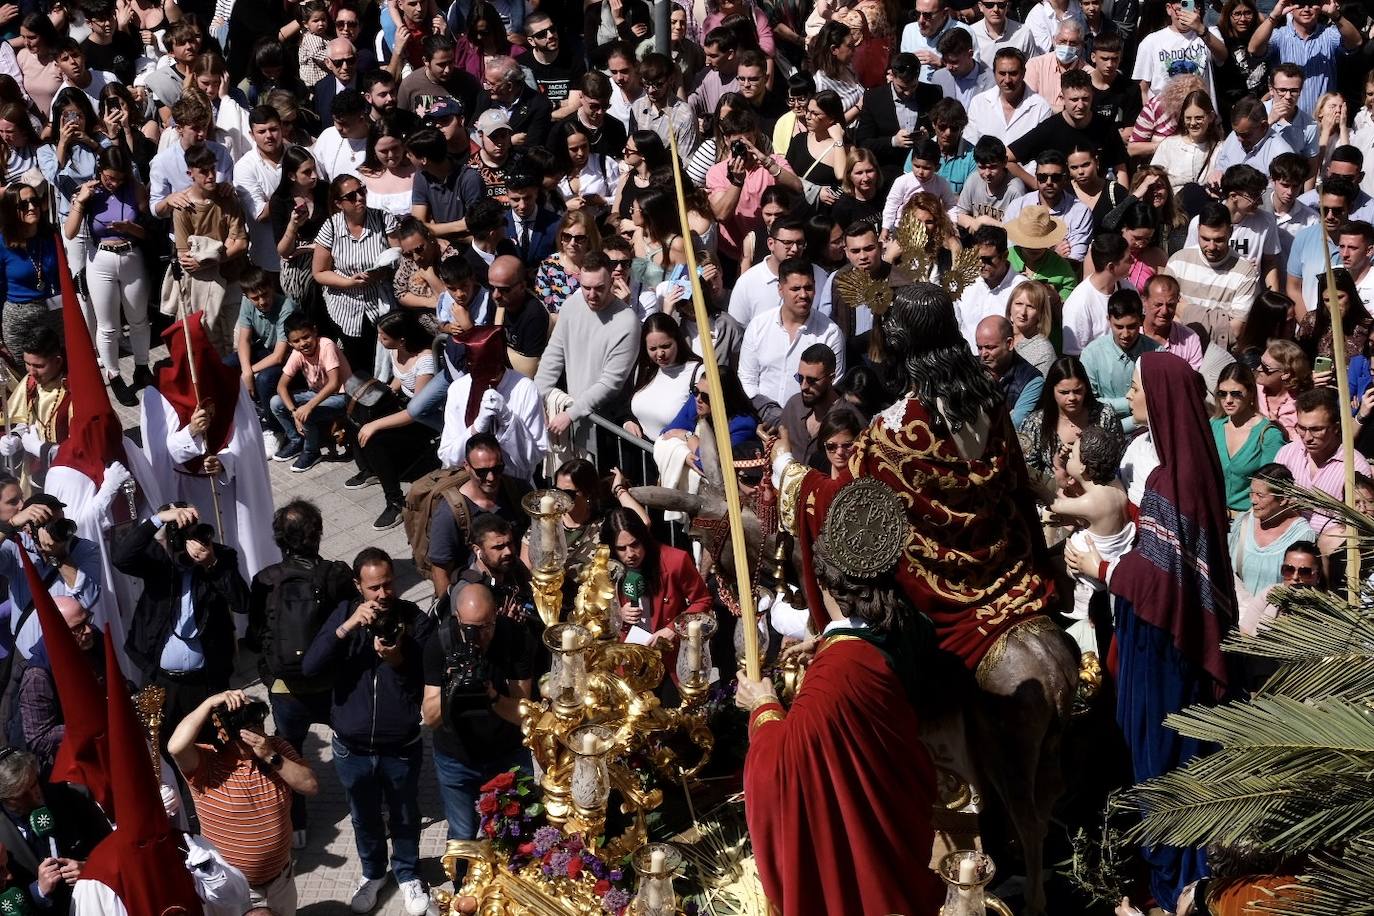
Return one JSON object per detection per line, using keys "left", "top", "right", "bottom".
{"left": 438, "top": 369, "right": 548, "bottom": 482}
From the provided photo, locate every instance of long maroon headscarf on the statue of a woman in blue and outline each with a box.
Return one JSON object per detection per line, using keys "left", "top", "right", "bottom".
{"left": 1112, "top": 353, "right": 1237, "bottom": 698}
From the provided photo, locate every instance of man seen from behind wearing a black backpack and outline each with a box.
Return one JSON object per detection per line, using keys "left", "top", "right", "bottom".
{"left": 249, "top": 500, "right": 357, "bottom": 849}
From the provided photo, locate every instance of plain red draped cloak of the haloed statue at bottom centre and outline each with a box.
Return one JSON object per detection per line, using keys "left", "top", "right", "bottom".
{"left": 745, "top": 630, "right": 944, "bottom": 916}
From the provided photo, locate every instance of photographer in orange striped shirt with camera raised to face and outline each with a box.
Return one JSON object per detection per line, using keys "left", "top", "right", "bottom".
{"left": 168, "top": 691, "right": 319, "bottom": 913}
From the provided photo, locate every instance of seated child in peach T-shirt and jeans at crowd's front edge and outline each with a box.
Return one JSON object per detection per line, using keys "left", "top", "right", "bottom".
{"left": 272, "top": 312, "right": 352, "bottom": 474}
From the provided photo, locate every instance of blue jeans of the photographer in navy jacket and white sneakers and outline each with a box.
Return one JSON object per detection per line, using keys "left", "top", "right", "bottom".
{"left": 331, "top": 737, "right": 425, "bottom": 884}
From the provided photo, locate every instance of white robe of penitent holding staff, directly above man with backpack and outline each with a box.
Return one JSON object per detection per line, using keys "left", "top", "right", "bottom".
{"left": 142, "top": 385, "right": 282, "bottom": 582}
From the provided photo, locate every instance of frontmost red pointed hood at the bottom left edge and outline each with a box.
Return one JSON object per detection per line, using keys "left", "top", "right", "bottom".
{"left": 81, "top": 628, "right": 205, "bottom": 916}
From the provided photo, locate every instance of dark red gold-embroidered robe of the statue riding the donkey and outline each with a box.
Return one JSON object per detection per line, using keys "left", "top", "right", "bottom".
{"left": 797, "top": 398, "right": 1054, "bottom": 669}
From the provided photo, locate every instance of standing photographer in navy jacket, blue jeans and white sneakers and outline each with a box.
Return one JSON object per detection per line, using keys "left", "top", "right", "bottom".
{"left": 301, "top": 547, "right": 433, "bottom": 916}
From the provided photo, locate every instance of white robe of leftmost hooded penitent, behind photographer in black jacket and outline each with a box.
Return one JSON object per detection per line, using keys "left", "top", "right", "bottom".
{"left": 44, "top": 437, "right": 166, "bottom": 677}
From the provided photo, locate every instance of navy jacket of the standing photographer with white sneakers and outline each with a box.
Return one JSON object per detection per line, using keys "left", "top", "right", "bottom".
{"left": 301, "top": 599, "right": 434, "bottom": 754}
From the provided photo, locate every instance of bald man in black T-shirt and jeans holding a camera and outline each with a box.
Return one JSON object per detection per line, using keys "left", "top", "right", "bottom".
{"left": 423, "top": 582, "right": 536, "bottom": 839}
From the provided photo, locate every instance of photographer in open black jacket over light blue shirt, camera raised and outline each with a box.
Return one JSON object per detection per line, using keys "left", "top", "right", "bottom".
{"left": 110, "top": 503, "right": 249, "bottom": 722}
